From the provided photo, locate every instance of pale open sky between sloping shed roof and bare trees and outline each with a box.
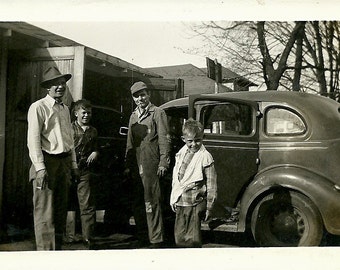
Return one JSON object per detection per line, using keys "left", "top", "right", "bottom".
{"left": 28, "top": 21, "right": 206, "bottom": 68}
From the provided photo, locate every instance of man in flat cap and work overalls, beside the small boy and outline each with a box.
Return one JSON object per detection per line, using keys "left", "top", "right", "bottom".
{"left": 126, "top": 81, "right": 170, "bottom": 247}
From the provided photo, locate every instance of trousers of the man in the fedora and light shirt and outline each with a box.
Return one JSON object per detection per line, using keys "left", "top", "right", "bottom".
{"left": 31, "top": 154, "right": 72, "bottom": 250}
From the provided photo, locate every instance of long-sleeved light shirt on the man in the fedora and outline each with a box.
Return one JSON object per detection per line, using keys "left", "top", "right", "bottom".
{"left": 27, "top": 95, "right": 77, "bottom": 171}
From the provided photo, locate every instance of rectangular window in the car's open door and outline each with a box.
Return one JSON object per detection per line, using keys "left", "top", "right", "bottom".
{"left": 201, "top": 102, "right": 253, "bottom": 135}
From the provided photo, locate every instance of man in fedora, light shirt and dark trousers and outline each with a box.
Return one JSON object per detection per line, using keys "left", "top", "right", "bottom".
{"left": 27, "top": 66, "right": 79, "bottom": 250}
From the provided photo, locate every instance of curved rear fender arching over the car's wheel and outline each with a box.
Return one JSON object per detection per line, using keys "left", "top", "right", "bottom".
{"left": 238, "top": 165, "right": 340, "bottom": 234}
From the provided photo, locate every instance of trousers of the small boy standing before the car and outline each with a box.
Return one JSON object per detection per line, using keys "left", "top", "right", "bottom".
{"left": 174, "top": 200, "right": 207, "bottom": 247}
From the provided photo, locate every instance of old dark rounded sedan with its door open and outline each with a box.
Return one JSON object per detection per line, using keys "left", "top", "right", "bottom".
{"left": 161, "top": 91, "right": 340, "bottom": 246}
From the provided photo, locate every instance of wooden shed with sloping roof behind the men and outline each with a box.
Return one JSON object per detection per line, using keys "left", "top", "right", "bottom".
{"left": 0, "top": 22, "right": 183, "bottom": 229}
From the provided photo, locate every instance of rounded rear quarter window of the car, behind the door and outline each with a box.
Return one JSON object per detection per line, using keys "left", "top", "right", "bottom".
{"left": 265, "top": 107, "right": 306, "bottom": 136}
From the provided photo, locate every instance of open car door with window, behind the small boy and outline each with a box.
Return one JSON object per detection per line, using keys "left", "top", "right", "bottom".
{"left": 189, "top": 96, "right": 261, "bottom": 213}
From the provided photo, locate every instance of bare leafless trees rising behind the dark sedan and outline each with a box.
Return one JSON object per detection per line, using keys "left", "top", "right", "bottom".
{"left": 192, "top": 21, "right": 340, "bottom": 98}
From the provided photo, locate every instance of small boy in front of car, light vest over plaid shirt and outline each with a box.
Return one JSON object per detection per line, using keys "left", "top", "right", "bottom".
{"left": 170, "top": 119, "right": 217, "bottom": 247}
